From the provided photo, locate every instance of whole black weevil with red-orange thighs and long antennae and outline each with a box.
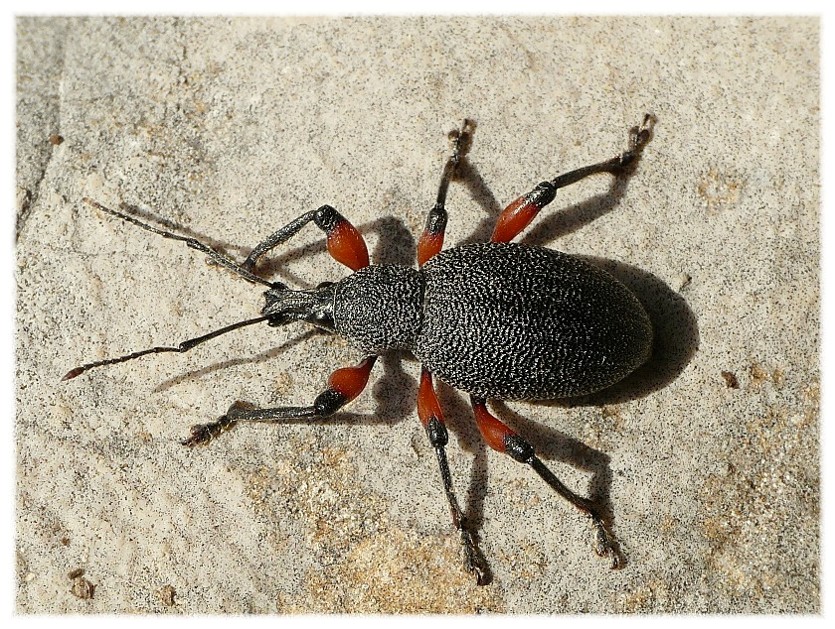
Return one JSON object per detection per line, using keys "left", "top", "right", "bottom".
{"left": 64, "top": 114, "right": 654, "bottom": 584}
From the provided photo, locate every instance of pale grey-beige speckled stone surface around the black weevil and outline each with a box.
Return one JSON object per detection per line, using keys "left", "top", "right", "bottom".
{"left": 16, "top": 17, "right": 820, "bottom": 613}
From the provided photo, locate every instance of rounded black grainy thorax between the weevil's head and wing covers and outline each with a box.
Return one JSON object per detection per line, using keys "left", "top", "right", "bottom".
{"left": 333, "top": 265, "right": 423, "bottom": 354}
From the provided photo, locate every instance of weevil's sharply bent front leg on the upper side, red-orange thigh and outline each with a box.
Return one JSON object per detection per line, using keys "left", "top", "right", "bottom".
{"left": 241, "top": 205, "right": 368, "bottom": 271}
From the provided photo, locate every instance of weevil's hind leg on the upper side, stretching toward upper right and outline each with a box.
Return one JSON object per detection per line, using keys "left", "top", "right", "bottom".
{"left": 490, "top": 114, "right": 655, "bottom": 242}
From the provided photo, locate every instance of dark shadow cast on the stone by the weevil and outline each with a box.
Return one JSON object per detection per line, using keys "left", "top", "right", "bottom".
{"left": 134, "top": 135, "right": 699, "bottom": 578}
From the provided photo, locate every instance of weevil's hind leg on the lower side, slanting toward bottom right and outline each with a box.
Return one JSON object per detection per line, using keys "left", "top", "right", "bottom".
{"left": 470, "top": 396, "right": 623, "bottom": 570}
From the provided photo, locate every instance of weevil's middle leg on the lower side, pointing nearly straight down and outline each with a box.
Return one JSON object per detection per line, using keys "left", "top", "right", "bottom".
{"left": 417, "top": 367, "right": 489, "bottom": 585}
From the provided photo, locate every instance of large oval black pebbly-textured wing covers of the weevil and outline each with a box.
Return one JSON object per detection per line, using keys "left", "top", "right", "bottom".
{"left": 412, "top": 243, "right": 652, "bottom": 399}
